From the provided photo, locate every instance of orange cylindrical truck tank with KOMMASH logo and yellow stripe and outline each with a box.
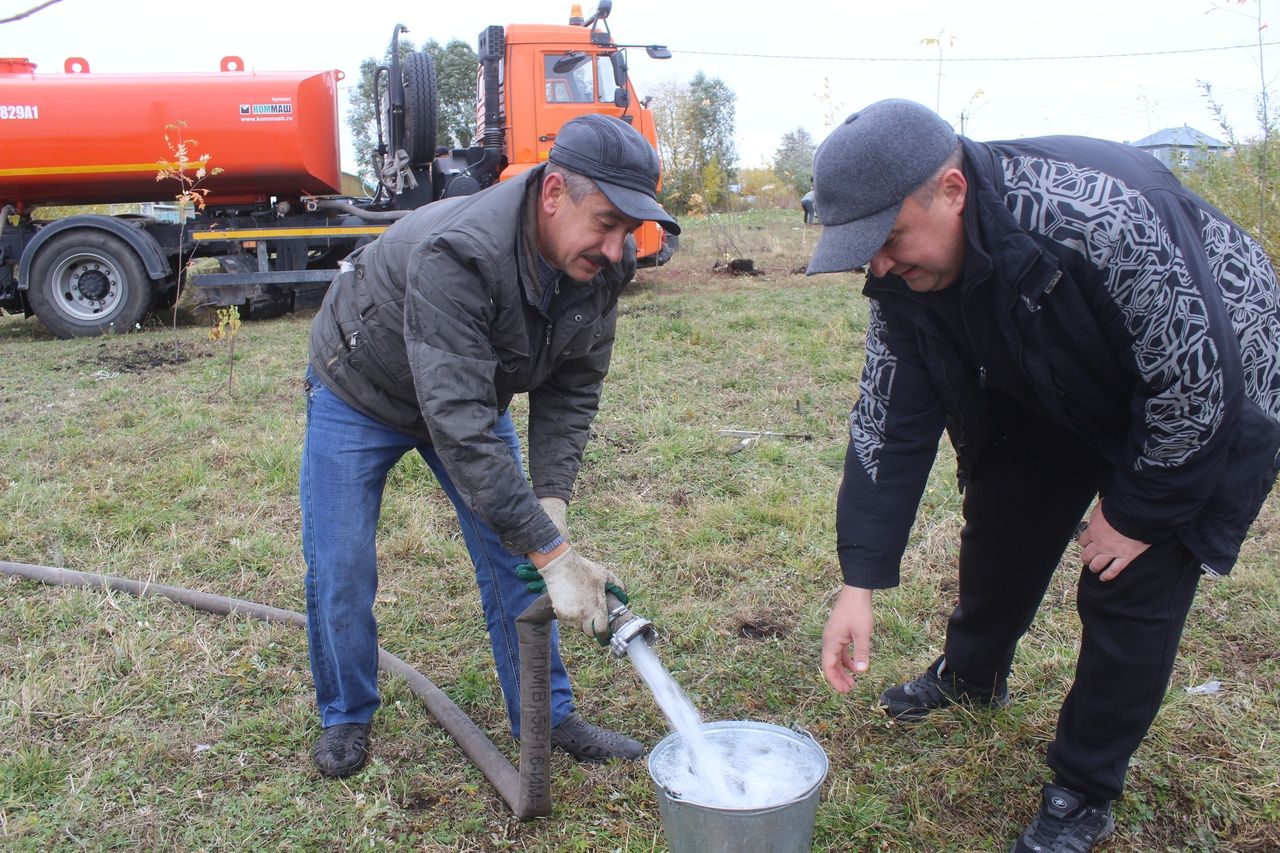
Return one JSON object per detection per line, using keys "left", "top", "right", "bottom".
{"left": 0, "top": 56, "right": 343, "bottom": 210}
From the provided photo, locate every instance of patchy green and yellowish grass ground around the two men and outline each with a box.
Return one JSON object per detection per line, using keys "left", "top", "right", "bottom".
{"left": 0, "top": 213, "right": 1280, "bottom": 852}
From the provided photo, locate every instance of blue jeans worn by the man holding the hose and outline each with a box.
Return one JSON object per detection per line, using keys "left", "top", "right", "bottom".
{"left": 298, "top": 368, "right": 573, "bottom": 738}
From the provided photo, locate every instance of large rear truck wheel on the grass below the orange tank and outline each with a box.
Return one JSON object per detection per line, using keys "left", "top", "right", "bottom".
{"left": 27, "top": 229, "right": 154, "bottom": 338}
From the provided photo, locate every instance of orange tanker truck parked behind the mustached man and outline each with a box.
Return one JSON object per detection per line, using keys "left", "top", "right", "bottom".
{"left": 0, "top": 0, "right": 675, "bottom": 338}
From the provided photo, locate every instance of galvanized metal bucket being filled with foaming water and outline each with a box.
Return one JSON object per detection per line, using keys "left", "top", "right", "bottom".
{"left": 649, "top": 721, "right": 827, "bottom": 853}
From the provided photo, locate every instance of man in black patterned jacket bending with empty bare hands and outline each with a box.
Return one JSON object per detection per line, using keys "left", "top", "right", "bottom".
{"left": 809, "top": 100, "right": 1280, "bottom": 853}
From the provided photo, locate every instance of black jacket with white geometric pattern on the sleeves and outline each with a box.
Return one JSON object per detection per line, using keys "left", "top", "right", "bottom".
{"left": 837, "top": 137, "right": 1280, "bottom": 589}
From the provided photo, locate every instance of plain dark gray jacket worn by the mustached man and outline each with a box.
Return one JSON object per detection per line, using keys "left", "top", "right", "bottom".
{"left": 311, "top": 168, "right": 635, "bottom": 553}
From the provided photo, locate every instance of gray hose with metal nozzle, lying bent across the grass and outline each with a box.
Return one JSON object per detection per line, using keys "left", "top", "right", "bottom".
{"left": 0, "top": 561, "right": 655, "bottom": 820}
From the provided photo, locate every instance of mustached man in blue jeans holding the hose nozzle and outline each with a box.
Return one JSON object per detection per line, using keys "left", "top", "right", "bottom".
{"left": 300, "top": 115, "right": 680, "bottom": 776}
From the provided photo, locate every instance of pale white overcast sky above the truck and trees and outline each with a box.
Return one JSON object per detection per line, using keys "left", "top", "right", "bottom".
{"left": 0, "top": 0, "right": 1280, "bottom": 169}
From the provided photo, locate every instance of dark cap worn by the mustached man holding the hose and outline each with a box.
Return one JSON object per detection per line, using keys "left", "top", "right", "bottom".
{"left": 549, "top": 113, "right": 680, "bottom": 234}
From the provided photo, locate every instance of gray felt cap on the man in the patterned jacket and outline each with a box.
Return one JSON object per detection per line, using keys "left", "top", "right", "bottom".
{"left": 805, "top": 99, "right": 957, "bottom": 275}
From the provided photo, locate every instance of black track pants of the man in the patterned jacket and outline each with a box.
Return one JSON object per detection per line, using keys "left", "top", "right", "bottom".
{"left": 946, "top": 415, "right": 1201, "bottom": 800}
